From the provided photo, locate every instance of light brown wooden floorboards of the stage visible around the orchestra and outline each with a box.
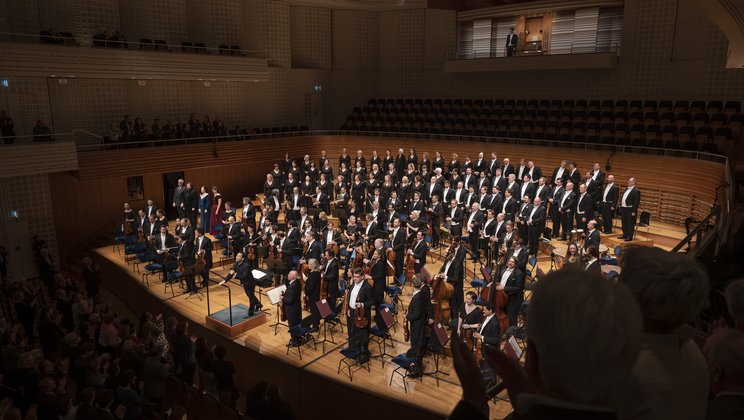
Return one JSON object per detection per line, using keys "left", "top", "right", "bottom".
{"left": 93, "top": 223, "right": 685, "bottom": 419}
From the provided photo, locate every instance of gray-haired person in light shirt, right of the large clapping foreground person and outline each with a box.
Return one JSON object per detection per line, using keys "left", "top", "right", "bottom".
{"left": 620, "top": 247, "right": 709, "bottom": 419}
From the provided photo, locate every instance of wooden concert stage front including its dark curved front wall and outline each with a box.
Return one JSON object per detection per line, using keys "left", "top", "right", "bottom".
{"left": 91, "top": 246, "right": 511, "bottom": 419}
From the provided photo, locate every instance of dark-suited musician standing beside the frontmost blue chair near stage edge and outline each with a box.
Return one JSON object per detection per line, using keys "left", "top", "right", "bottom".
{"left": 406, "top": 274, "right": 434, "bottom": 378}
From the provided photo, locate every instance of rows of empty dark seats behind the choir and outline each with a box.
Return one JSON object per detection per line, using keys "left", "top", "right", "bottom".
{"left": 341, "top": 99, "right": 744, "bottom": 153}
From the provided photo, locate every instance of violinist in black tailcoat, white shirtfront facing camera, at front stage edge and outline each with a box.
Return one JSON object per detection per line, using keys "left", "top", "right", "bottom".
{"left": 346, "top": 267, "right": 375, "bottom": 363}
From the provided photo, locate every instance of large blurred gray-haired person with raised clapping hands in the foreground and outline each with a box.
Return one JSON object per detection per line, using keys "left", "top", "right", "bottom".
{"left": 450, "top": 267, "right": 642, "bottom": 420}
